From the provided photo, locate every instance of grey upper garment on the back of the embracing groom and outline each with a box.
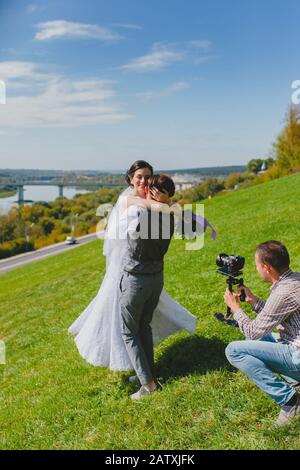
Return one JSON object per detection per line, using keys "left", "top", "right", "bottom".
{"left": 124, "top": 206, "right": 174, "bottom": 274}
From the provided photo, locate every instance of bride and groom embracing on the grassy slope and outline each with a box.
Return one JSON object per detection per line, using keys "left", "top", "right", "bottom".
{"left": 69, "top": 160, "right": 196, "bottom": 400}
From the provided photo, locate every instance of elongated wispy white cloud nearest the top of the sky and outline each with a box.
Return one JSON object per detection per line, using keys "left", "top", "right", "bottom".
{"left": 35, "top": 20, "right": 122, "bottom": 41}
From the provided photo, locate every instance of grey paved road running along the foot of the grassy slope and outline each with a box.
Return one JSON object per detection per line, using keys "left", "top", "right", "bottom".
{"left": 0, "top": 233, "right": 102, "bottom": 274}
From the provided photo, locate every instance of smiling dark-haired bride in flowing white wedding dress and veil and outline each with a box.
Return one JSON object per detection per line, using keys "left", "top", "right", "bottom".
{"left": 68, "top": 160, "right": 196, "bottom": 371}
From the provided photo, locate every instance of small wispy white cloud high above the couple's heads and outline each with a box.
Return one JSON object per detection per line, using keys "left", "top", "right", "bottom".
{"left": 121, "top": 43, "right": 184, "bottom": 72}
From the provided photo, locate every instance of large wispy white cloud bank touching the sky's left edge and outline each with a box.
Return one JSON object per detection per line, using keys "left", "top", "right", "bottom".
{"left": 0, "top": 62, "right": 133, "bottom": 130}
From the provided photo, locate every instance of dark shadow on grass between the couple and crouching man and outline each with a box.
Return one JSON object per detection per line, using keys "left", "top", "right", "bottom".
{"left": 156, "top": 336, "right": 233, "bottom": 380}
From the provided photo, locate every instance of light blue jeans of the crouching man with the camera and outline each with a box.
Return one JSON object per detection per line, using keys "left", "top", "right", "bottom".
{"left": 225, "top": 335, "right": 300, "bottom": 406}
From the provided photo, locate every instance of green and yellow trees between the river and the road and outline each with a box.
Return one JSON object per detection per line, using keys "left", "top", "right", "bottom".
{"left": 0, "top": 187, "right": 122, "bottom": 259}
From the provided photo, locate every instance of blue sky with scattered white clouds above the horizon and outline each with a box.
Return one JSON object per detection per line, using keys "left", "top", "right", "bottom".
{"left": 0, "top": 0, "right": 300, "bottom": 170}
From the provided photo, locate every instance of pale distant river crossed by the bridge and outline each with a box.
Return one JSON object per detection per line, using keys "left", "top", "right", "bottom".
{"left": 0, "top": 186, "right": 90, "bottom": 215}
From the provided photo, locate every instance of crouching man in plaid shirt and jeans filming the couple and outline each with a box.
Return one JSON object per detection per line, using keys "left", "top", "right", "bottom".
{"left": 224, "top": 240, "right": 300, "bottom": 426}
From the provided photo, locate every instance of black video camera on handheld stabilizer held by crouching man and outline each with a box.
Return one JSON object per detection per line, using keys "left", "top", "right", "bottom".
{"left": 214, "top": 253, "right": 246, "bottom": 327}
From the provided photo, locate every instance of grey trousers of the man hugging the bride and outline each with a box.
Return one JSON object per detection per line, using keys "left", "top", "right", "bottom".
{"left": 120, "top": 271, "right": 163, "bottom": 385}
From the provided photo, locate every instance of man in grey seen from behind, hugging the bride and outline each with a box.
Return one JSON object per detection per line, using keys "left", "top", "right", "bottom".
{"left": 120, "top": 175, "right": 175, "bottom": 400}
